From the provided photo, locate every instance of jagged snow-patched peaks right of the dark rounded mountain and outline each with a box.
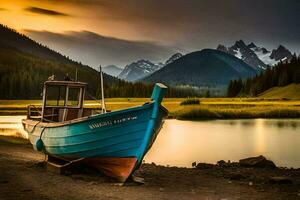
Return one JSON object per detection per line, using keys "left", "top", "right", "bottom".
{"left": 217, "top": 40, "right": 292, "bottom": 71}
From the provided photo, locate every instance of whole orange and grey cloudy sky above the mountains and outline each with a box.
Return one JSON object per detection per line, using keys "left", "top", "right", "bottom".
{"left": 0, "top": 0, "right": 300, "bottom": 67}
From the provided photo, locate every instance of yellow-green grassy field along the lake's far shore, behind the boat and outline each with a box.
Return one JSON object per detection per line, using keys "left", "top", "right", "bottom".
{"left": 0, "top": 98, "right": 300, "bottom": 120}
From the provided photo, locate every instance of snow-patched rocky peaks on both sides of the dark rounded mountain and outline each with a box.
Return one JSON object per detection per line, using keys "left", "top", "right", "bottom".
{"left": 117, "top": 40, "right": 292, "bottom": 81}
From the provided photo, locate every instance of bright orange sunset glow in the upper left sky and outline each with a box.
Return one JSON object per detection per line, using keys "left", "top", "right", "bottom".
{"left": 0, "top": 0, "right": 145, "bottom": 39}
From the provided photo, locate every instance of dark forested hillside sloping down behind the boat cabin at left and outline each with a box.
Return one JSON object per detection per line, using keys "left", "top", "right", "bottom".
{"left": 0, "top": 25, "right": 118, "bottom": 99}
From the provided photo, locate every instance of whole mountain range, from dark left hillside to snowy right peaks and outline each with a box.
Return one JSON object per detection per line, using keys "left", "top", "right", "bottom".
{"left": 0, "top": 22, "right": 292, "bottom": 99}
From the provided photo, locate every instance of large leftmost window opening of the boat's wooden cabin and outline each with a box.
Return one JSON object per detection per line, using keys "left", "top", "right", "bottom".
{"left": 46, "top": 86, "right": 66, "bottom": 106}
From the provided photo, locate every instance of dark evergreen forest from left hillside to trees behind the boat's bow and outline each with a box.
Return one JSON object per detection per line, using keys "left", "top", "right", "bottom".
{"left": 0, "top": 24, "right": 201, "bottom": 100}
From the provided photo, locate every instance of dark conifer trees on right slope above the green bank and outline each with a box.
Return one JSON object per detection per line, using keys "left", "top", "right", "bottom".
{"left": 227, "top": 54, "right": 300, "bottom": 97}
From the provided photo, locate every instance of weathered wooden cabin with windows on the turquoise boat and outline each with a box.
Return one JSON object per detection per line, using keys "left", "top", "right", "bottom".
{"left": 28, "top": 81, "right": 96, "bottom": 122}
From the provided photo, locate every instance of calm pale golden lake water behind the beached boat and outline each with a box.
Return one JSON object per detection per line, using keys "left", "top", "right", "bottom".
{"left": 0, "top": 116, "right": 300, "bottom": 168}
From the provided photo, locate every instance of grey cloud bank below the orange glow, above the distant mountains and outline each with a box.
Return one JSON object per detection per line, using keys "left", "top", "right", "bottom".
{"left": 25, "top": 30, "right": 175, "bottom": 67}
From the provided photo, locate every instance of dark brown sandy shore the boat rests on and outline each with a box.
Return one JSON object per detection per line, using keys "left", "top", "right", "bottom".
{"left": 0, "top": 137, "right": 300, "bottom": 200}
